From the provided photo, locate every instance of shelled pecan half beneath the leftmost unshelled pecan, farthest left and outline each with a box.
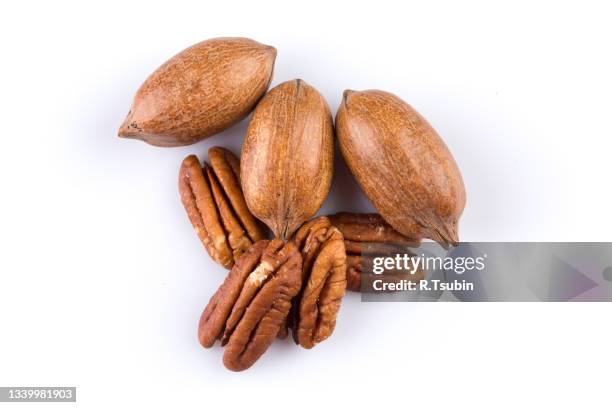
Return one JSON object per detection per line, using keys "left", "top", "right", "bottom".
{"left": 179, "top": 147, "right": 264, "bottom": 269}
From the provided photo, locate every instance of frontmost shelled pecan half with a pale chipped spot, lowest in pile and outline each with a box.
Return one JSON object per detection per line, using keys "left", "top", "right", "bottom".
{"left": 198, "top": 239, "right": 302, "bottom": 371}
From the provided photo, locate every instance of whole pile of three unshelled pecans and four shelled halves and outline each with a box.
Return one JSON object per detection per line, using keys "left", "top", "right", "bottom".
{"left": 119, "top": 38, "right": 465, "bottom": 371}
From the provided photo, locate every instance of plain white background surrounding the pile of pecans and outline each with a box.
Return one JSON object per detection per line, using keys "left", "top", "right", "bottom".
{"left": 0, "top": 0, "right": 612, "bottom": 407}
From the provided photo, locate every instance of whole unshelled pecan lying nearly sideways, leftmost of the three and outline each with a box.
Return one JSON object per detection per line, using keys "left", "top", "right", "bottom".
{"left": 119, "top": 38, "right": 276, "bottom": 147}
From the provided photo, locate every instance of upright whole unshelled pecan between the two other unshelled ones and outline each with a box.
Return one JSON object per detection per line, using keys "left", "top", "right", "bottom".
{"left": 240, "top": 79, "right": 334, "bottom": 240}
